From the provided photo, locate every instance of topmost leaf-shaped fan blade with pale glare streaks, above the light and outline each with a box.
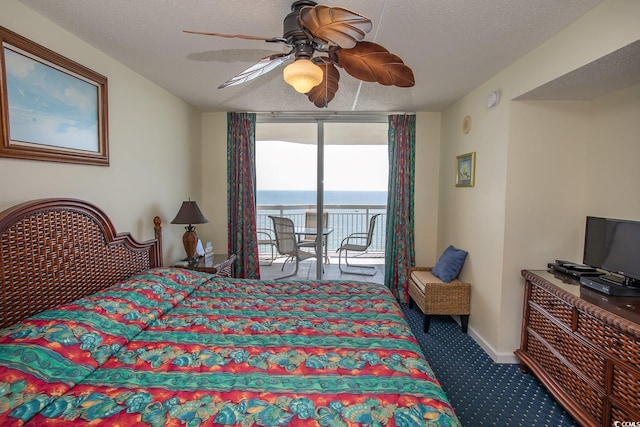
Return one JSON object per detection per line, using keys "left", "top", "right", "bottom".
{"left": 298, "top": 5, "right": 373, "bottom": 49}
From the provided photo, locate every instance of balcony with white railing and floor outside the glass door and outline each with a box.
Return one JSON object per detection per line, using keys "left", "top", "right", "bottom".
{"left": 256, "top": 205, "right": 387, "bottom": 283}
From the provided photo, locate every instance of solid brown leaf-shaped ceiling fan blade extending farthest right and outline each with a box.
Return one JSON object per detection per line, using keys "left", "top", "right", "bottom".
{"left": 336, "top": 42, "right": 415, "bottom": 87}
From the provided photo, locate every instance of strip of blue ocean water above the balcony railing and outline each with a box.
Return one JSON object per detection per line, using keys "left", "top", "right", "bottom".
{"left": 256, "top": 190, "right": 387, "bottom": 205}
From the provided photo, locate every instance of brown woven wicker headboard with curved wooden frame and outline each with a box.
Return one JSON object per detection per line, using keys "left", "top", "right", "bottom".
{"left": 0, "top": 199, "right": 162, "bottom": 328}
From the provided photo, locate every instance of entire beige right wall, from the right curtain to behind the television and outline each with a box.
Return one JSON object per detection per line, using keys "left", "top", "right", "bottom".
{"left": 438, "top": 0, "right": 640, "bottom": 361}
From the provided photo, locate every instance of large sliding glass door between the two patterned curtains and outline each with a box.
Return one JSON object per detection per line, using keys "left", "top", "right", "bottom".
{"left": 256, "top": 114, "right": 388, "bottom": 279}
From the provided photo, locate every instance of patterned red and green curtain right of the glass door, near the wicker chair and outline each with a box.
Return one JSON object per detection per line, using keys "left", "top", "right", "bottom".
{"left": 384, "top": 114, "right": 416, "bottom": 302}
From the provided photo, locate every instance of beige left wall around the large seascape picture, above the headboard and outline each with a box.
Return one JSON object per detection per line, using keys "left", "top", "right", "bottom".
{"left": 0, "top": 0, "right": 200, "bottom": 262}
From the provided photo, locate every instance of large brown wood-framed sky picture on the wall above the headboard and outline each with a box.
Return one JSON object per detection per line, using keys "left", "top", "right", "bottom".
{"left": 0, "top": 27, "right": 109, "bottom": 166}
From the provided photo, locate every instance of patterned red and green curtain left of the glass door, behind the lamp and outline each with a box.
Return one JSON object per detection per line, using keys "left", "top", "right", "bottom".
{"left": 227, "top": 113, "right": 260, "bottom": 279}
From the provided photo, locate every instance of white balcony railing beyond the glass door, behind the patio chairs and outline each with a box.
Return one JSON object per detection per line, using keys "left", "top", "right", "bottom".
{"left": 256, "top": 205, "right": 387, "bottom": 256}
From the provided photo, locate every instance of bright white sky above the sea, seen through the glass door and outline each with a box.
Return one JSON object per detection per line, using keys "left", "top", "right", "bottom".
{"left": 256, "top": 141, "right": 389, "bottom": 191}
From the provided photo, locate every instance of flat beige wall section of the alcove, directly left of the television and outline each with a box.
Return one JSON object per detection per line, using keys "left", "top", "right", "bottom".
{"left": 499, "top": 101, "right": 589, "bottom": 352}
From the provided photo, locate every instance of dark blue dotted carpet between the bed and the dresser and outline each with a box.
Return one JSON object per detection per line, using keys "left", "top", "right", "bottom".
{"left": 400, "top": 304, "right": 578, "bottom": 427}
